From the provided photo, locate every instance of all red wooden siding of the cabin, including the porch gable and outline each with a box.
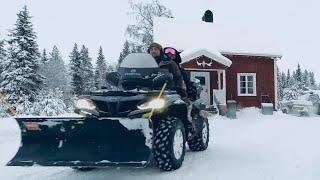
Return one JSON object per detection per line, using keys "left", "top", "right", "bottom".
{"left": 182, "top": 54, "right": 275, "bottom": 108}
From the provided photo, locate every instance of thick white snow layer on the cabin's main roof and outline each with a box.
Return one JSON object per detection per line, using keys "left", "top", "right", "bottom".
{"left": 154, "top": 18, "right": 282, "bottom": 58}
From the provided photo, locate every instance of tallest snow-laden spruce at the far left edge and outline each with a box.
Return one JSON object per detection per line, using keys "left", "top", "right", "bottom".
{"left": 0, "top": 6, "right": 43, "bottom": 105}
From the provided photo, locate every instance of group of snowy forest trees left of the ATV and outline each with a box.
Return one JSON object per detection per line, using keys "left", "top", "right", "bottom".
{"left": 0, "top": 6, "right": 114, "bottom": 117}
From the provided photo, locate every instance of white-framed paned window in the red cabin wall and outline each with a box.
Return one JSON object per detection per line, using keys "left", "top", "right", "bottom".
{"left": 238, "top": 73, "right": 257, "bottom": 96}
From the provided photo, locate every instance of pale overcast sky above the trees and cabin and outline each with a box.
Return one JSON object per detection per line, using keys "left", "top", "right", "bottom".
{"left": 0, "top": 0, "right": 320, "bottom": 79}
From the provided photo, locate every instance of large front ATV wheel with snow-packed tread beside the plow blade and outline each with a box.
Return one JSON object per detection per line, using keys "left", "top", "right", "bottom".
{"left": 153, "top": 117, "right": 186, "bottom": 171}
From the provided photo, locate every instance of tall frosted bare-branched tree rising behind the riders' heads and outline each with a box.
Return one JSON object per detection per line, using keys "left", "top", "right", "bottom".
{"left": 127, "top": 0, "right": 172, "bottom": 52}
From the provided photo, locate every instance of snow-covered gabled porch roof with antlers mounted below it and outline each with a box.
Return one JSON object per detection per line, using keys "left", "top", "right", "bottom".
{"left": 180, "top": 48, "right": 232, "bottom": 67}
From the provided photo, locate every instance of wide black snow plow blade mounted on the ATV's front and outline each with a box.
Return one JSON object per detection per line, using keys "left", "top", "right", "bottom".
{"left": 7, "top": 117, "right": 152, "bottom": 167}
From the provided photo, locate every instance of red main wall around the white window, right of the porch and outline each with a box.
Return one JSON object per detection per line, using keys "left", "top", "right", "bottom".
{"left": 225, "top": 55, "right": 275, "bottom": 108}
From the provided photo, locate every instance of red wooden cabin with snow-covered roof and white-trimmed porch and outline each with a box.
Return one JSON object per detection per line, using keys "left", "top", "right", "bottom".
{"left": 154, "top": 18, "right": 282, "bottom": 109}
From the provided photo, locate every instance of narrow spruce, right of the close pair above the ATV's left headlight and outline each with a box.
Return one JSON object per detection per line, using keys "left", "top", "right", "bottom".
{"left": 80, "top": 45, "right": 94, "bottom": 94}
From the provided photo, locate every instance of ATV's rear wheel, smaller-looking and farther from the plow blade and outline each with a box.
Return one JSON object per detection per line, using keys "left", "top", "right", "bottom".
{"left": 188, "top": 116, "right": 209, "bottom": 151}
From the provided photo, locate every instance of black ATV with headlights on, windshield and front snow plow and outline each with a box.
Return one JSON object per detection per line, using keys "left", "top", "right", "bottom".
{"left": 7, "top": 53, "right": 209, "bottom": 171}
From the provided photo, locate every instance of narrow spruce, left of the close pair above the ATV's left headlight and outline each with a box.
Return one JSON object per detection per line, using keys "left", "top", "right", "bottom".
{"left": 69, "top": 44, "right": 84, "bottom": 95}
